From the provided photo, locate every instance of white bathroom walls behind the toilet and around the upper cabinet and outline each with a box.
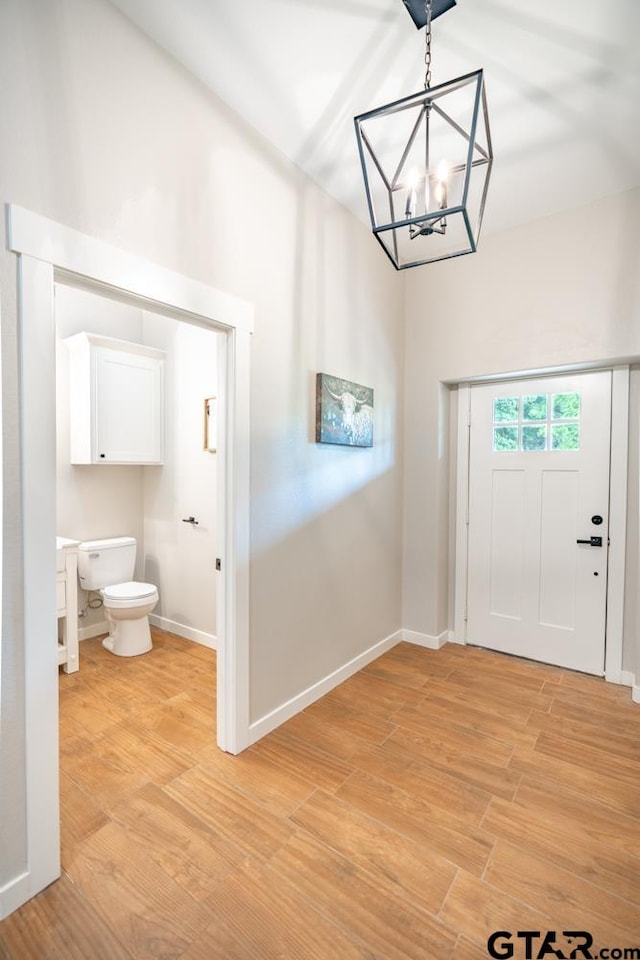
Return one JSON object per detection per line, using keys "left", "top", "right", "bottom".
{"left": 56, "top": 284, "right": 217, "bottom": 646}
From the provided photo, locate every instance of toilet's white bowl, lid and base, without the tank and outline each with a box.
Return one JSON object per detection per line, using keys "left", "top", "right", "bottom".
{"left": 100, "top": 580, "right": 158, "bottom": 657}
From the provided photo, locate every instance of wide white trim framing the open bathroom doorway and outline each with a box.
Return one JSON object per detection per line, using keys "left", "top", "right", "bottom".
{"left": 6, "top": 204, "right": 254, "bottom": 915}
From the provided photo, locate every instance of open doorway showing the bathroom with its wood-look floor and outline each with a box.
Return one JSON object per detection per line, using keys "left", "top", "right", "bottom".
{"left": 55, "top": 283, "right": 224, "bottom": 840}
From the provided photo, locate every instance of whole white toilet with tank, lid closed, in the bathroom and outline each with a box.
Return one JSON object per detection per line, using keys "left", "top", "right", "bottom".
{"left": 78, "top": 537, "right": 158, "bottom": 657}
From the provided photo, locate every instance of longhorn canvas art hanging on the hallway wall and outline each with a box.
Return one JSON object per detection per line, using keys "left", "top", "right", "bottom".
{"left": 316, "top": 373, "right": 373, "bottom": 447}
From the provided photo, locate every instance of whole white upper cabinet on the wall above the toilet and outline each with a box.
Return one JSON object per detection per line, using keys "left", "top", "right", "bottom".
{"left": 66, "top": 333, "right": 165, "bottom": 464}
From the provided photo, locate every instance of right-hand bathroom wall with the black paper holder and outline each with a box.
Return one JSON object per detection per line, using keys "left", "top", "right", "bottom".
{"left": 143, "top": 313, "right": 218, "bottom": 646}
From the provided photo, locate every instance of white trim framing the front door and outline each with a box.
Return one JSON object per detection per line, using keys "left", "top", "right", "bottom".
{"left": 453, "top": 364, "right": 629, "bottom": 683}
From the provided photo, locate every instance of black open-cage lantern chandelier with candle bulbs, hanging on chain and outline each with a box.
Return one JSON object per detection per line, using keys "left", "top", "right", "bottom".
{"left": 354, "top": 0, "right": 493, "bottom": 270}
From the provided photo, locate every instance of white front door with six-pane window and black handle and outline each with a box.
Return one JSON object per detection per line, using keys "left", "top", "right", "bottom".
{"left": 467, "top": 371, "right": 611, "bottom": 675}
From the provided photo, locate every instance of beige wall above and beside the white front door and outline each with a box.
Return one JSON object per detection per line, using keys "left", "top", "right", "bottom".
{"left": 403, "top": 189, "right": 640, "bottom": 672}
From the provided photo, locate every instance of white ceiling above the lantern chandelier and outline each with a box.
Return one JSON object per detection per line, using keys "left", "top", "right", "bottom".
{"left": 112, "top": 0, "right": 640, "bottom": 238}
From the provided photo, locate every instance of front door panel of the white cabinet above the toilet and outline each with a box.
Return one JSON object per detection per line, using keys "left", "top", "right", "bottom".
{"left": 93, "top": 347, "right": 163, "bottom": 463}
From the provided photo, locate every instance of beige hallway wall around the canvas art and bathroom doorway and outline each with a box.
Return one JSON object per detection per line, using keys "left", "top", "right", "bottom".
{"left": 0, "top": 0, "right": 404, "bottom": 888}
